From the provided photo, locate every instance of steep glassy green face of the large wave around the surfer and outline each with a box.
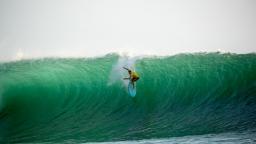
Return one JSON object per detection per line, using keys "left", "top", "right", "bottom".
{"left": 0, "top": 53, "right": 256, "bottom": 142}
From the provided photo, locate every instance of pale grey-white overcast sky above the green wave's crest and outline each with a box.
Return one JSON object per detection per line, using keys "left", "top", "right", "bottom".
{"left": 0, "top": 0, "right": 256, "bottom": 60}
